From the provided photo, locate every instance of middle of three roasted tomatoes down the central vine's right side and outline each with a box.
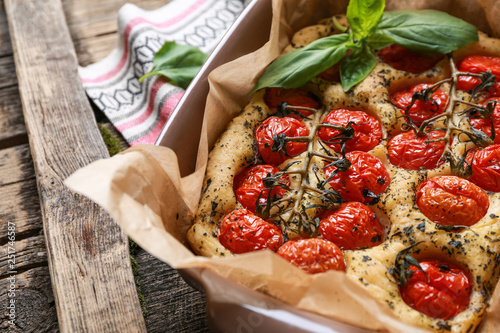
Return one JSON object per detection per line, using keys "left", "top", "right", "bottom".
{"left": 325, "top": 151, "right": 391, "bottom": 203}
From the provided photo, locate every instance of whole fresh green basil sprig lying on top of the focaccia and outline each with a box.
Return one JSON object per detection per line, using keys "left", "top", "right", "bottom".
{"left": 254, "top": 0, "right": 478, "bottom": 91}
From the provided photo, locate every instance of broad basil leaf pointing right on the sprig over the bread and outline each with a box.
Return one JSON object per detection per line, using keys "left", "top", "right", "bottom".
{"left": 377, "top": 10, "right": 478, "bottom": 55}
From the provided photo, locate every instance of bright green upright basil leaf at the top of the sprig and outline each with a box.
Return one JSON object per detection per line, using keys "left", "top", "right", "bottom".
{"left": 346, "top": 0, "right": 385, "bottom": 41}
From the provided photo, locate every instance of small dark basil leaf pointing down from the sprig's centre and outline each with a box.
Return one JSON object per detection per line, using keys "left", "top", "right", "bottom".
{"left": 340, "top": 47, "right": 377, "bottom": 91}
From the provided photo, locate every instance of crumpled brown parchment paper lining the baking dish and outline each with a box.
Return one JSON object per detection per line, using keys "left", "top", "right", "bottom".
{"left": 66, "top": 0, "right": 500, "bottom": 332}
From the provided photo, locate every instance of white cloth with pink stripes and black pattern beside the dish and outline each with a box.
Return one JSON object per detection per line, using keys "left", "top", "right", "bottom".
{"left": 79, "top": 0, "right": 250, "bottom": 145}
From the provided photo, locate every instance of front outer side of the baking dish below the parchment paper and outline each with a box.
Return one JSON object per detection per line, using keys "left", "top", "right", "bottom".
{"left": 179, "top": 268, "right": 371, "bottom": 333}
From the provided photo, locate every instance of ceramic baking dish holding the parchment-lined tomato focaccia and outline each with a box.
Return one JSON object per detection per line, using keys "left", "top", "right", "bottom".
{"left": 156, "top": 0, "right": 374, "bottom": 333}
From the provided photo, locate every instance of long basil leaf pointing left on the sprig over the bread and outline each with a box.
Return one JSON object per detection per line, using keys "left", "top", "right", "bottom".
{"left": 253, "top": 34, "right": 353, "bottom": 92}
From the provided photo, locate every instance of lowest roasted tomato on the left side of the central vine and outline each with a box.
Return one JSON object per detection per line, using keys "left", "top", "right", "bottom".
{"left": 219, "top": 209, "right": 283, "bottom": 253}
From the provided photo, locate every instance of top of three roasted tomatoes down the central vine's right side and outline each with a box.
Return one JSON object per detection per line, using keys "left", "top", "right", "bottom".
{"left": 318, "top": 109, "right": 382, "bottom": 152}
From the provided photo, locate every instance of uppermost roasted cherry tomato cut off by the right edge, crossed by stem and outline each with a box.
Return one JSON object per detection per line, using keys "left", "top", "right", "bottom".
{"left": 457, "top": 55, "right": 500, "bottom": 97}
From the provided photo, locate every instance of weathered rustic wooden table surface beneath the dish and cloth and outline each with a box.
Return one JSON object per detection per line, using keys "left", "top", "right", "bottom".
{"left": 0, "top": 0, "right": 208, "bottom": 332}
